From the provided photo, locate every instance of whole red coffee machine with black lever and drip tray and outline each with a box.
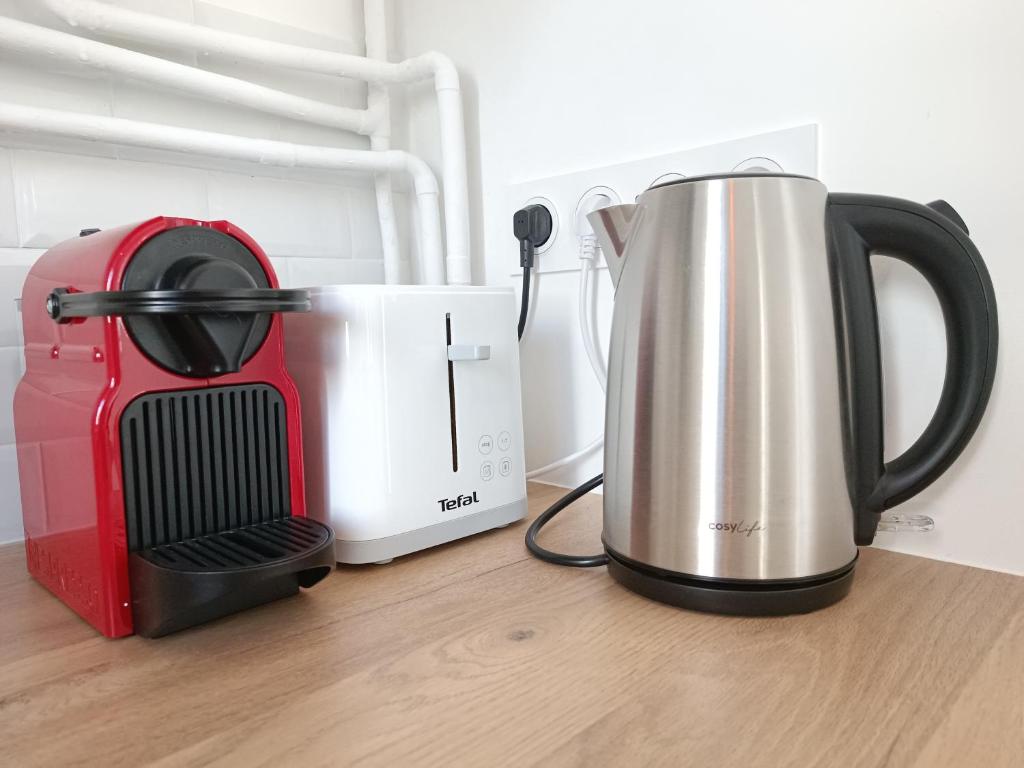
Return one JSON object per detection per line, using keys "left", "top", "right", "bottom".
{"left": 14, "top": 217, "right": 334, "bottom": 637}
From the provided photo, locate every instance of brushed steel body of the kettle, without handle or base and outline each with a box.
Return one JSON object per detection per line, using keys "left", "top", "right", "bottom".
{"left": 594, "top": 176, "right": 856, "bottom": 580}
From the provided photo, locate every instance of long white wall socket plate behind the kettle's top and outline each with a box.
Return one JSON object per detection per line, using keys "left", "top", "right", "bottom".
{"left": 506, "top": 125, "right": 818, "bottom": 274}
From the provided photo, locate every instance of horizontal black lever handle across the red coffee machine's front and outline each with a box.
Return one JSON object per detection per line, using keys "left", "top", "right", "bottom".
{"left": 46, "top": 288, "right": 310, "bottom": 323}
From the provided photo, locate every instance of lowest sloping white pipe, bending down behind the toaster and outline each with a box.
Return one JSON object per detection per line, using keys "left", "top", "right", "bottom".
{"left": 0, "top": 102, "right": 444, "bottom": 285}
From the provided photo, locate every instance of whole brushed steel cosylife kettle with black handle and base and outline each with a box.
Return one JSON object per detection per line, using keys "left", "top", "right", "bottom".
{"left": 589, "top": 174, "right": 997, "bottom": 614}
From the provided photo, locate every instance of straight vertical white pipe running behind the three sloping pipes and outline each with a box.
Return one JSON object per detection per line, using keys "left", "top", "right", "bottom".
{"left": 362, "top": 0, "right": 409, "bottom": 285}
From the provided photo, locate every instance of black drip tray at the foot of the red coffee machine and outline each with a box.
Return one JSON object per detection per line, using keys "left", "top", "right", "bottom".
{"left": 129, "top": 517, "right": 335, "bottom": 637}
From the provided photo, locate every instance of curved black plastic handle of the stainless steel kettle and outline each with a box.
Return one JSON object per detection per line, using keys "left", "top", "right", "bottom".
{"left": 827, "top": 195, "right": 998, "bottom": 544}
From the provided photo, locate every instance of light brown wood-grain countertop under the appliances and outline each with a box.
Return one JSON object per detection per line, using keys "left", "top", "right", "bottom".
{"left": 0, "top": 485, "right": 1024, "bottom": 768}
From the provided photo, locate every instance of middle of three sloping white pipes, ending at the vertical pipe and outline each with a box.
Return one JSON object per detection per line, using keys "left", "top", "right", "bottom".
{"left": 0, "top": 16, "right": 377, "bottom": 134}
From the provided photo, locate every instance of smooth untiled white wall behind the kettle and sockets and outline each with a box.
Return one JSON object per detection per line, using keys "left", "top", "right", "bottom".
{"left": 396, "top": 0, "right": 1024, "bottom": 573}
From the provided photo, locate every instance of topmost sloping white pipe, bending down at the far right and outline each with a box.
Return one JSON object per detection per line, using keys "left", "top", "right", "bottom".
{"left": 37, "top": 0, "right": 472, "bottom": 285}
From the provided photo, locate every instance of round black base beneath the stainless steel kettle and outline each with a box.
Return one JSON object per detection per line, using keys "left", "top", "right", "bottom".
{"left": 605, "top": 547, "right": 857, "bottom": 616}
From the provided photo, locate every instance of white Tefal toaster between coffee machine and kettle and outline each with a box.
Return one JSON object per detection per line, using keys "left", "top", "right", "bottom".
{"left": 285, "top": 285, "right": 526, "bottom": 563}
